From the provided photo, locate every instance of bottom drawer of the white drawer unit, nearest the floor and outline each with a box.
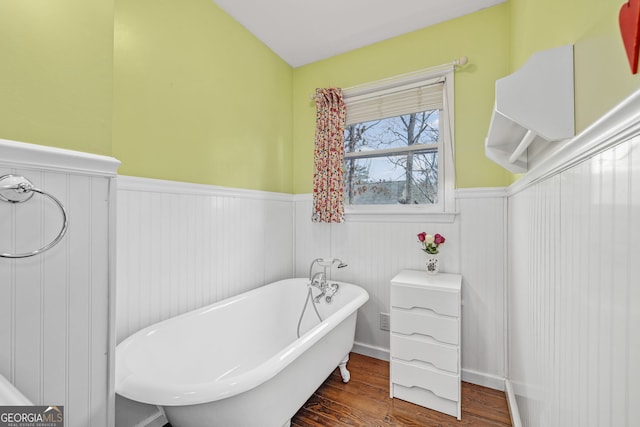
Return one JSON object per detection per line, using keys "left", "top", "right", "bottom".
{"left": 391, "top": 360, "right": 460, "bottom": 402}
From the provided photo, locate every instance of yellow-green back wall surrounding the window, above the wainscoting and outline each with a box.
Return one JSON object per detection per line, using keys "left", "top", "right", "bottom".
{"left": 293, "top": 4, "right": 510, "bottom": 193}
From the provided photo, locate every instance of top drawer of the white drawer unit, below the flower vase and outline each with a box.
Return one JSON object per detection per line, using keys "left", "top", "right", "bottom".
{"left": 391, "top": 283, "right": 460, "bottom": 317}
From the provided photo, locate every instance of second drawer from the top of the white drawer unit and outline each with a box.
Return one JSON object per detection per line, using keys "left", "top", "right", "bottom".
{"left": 391, "top": 308, "right": 460, "bottom": 345}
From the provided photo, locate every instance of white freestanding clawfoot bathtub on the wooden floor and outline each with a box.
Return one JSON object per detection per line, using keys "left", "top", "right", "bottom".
{"left": 116, "top": 279, "right": 369, "bottom": 427}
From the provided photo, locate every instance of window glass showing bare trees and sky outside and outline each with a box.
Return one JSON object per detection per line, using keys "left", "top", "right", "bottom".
{"left": 344, "top": 109, "right": 441, "bottom": 205}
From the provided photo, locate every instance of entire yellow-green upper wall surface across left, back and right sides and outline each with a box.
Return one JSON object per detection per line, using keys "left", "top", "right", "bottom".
{"left": 5, "top": 0, "right": 640, "bottom": 193}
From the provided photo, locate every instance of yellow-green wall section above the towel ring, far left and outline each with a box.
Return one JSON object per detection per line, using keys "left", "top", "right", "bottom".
{"left": 0, "top": 0, "right": 113, "bottom": 154}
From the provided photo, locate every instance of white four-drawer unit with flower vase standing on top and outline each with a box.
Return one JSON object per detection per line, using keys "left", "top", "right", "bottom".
{"left": 390, "top": 270, "right": 462, "bottom": 419}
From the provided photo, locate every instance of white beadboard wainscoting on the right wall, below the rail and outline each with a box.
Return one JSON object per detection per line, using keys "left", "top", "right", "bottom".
{"left": 508, "top": 137, "right": 640, "bottom": 427}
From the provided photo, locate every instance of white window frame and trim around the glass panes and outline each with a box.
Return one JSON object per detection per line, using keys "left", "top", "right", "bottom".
{"left": 343, "top": 64, "right": 455, "bottom": 222}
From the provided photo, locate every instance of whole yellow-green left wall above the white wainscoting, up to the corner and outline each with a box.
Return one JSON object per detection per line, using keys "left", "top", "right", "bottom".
{"left": 0, "top": 0, "right": 293, "bottom": 192}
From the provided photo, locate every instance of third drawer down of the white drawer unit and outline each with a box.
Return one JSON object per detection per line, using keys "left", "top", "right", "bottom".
{"left": 391, "top": 333, "right": 458, "bottom": 374}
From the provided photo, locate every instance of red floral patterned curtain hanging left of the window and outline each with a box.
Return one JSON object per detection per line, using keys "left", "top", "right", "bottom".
{"left": 311, "top": 88, "right": 347, "bottom": 226}
